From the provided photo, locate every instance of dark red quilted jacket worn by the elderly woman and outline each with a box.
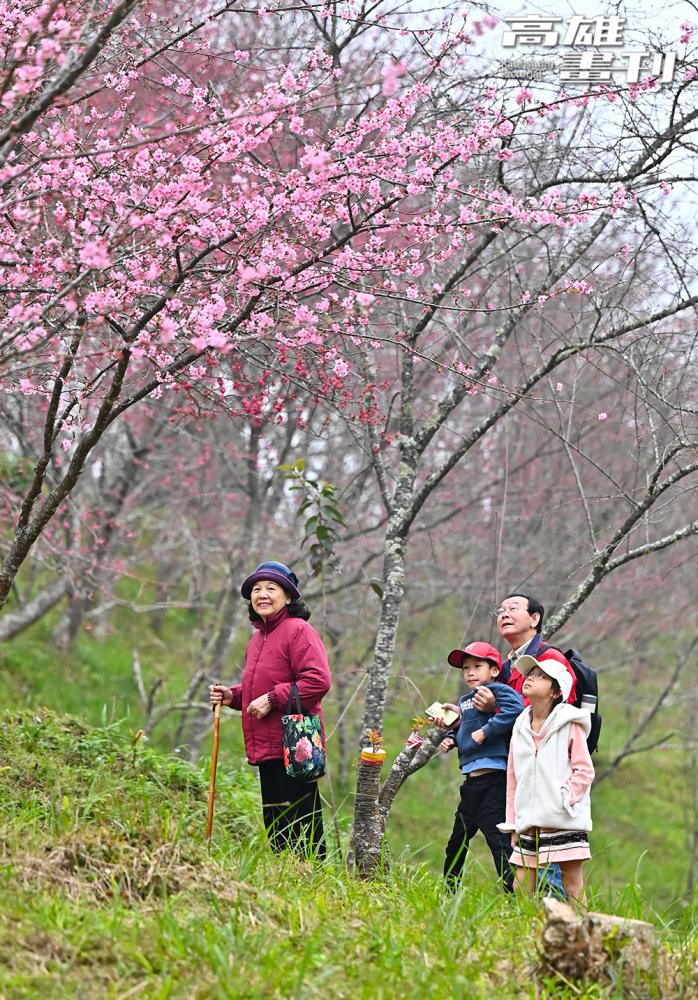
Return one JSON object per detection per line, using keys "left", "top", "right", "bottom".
{"left": 226, "top": 608, "right": 332, "bottom": 764}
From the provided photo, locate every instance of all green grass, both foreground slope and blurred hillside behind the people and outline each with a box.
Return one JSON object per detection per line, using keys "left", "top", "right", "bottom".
{"left": 0, "top": 608, "right": 698, "bottom": 1000}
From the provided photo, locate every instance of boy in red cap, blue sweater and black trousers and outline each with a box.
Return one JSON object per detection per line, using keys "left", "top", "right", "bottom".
{"left": 439, "top": 642, "right": 524, "bottom": 892}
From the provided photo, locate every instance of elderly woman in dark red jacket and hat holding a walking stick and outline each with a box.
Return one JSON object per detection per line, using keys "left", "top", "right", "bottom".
{"left": 209, "top": 561, "right": 331, "bottom": 857}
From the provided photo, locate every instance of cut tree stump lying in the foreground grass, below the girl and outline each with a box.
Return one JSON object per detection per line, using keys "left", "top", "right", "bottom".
{"left": 541, "top": 899, "right": 666, "bottom": 996}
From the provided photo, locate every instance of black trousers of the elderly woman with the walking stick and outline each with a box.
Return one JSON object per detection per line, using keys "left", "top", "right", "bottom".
{"left": 259, "top": 760, "right": 326, "bottom": 858}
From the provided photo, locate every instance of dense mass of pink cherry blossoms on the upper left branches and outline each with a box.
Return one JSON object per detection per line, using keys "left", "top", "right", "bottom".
{"left": 0, "top": 0, "right": 636, "bottom": 430}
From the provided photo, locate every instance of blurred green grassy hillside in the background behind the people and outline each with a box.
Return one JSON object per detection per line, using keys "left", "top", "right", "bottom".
{"left": 0, "top": 609, "right": 689, "bottom": 912}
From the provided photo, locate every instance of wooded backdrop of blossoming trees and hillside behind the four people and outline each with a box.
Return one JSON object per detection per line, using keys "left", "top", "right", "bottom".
{"left": 0, "top": 0, "right": 698, "bottom": 992}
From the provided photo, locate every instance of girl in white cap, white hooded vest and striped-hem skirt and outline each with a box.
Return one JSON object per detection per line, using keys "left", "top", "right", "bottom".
{"left": 503, "top": 655, "right": 594, "bottom": 902}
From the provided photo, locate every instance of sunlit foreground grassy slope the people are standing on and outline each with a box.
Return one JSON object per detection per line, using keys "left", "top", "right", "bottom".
{"left": 0, "top": 709, "right": 698, "bottom": 1000}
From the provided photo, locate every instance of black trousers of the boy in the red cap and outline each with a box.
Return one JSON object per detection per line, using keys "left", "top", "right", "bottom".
{"left": 444, "top": 771, "right": 514, "bottom": 892}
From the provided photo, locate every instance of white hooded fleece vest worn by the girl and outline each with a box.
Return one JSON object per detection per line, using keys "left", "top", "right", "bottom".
{"left": 511, "top": 702, "right": 591, "bottom": 833}
